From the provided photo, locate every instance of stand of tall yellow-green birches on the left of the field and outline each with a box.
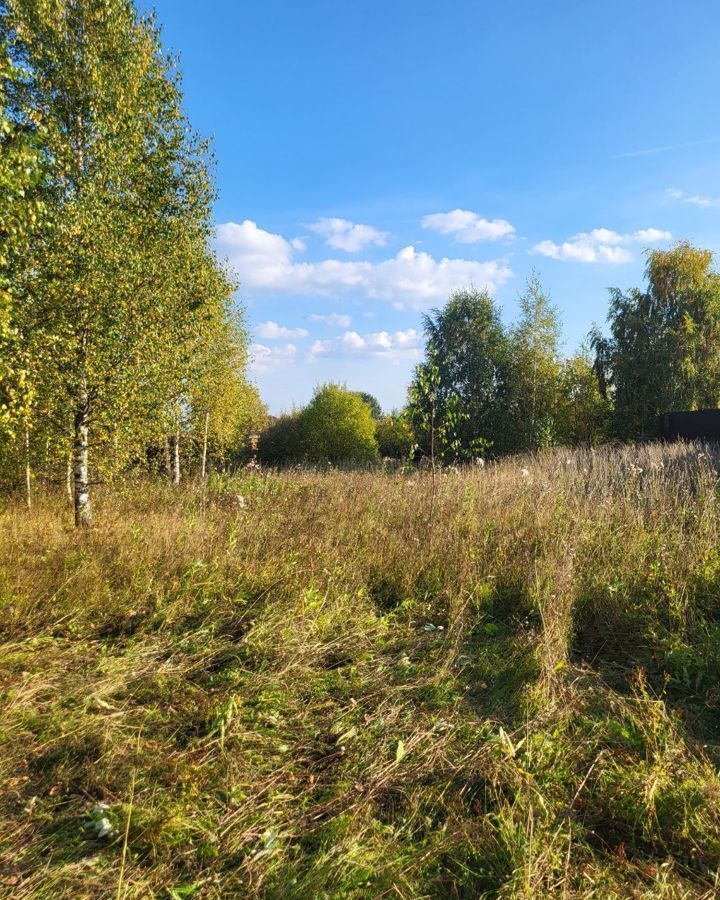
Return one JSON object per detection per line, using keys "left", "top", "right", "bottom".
{"left": 0, "top": 0, "right": 263, "bottom": 525}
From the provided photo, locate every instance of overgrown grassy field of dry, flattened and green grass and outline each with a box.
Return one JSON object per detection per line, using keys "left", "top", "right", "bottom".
{"left": 0, "top": 445, "right": 720, "bottom": 900}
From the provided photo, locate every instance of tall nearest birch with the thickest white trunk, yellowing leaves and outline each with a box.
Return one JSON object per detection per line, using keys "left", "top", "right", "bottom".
{"left": 0, "top": 0, "right": 221, "bottom": 526}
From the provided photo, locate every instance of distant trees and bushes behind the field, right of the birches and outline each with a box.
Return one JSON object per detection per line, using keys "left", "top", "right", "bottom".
{"left": 259, "top": 243, "right": 720, "bottom": 472}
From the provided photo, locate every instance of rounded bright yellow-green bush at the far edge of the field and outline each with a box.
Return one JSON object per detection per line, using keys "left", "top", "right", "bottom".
{"left": 300, "top": 384, "right": 378, "bottom": 463}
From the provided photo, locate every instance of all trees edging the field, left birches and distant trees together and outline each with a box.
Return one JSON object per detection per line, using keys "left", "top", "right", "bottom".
{"left": 0, "top": 0, "right": 720, "bottom": 500}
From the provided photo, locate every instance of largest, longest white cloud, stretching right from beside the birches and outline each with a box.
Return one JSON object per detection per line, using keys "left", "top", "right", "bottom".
{"left": 217, "top": 219, "right": 512, "bottom": 309}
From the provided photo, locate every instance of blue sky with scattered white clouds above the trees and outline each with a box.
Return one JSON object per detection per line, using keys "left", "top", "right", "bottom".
{"left": 142, "top": 0, "right": 720, "bottom": 412}
